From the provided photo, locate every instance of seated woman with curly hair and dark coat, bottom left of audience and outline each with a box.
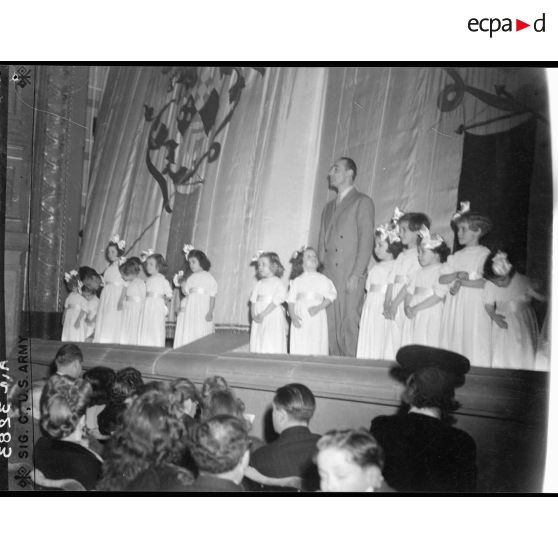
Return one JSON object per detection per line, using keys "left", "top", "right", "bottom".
{"left": 33, "top": 374, "right": 102, "bottom": 490}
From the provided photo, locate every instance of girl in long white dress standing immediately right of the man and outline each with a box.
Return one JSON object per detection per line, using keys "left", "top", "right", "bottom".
{"left": 357, "top": 224, "right": 403, "bottom": 360}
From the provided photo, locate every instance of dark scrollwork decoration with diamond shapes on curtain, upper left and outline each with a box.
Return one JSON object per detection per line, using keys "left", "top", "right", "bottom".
{"left": 144, "top": 66, "right": 265, "bottom": 213}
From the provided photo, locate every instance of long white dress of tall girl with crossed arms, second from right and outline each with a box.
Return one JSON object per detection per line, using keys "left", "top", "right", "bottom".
{"left": 440, "top": 246, "right": 492, "bottom": 367}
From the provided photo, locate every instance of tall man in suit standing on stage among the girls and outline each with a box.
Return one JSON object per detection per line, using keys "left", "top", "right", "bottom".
{"left": 318, "top": 157, "right": 374, "bottom": 357}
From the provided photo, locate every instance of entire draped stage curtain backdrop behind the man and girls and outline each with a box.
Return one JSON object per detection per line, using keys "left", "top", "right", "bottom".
{"left": 80, "top": 67, "right": 547, "bottom": 325}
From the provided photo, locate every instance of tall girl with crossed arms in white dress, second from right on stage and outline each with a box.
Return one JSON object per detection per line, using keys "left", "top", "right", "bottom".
{"left": 440, "top": 202, "right": 492, "bottom": 367}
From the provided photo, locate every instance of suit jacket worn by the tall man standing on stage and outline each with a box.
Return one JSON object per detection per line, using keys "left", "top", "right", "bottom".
{"left": 318, "top": 188, "right": 374, "bottom": 291}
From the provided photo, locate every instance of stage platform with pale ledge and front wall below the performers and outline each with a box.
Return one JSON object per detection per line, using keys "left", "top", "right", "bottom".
{"left": 9, "top": 330, "right": 549, "bottom": 493}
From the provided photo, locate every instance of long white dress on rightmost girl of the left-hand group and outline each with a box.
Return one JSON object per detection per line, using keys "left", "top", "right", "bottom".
{"left": 173, "top": 270, "right": 217, "bottom": 349}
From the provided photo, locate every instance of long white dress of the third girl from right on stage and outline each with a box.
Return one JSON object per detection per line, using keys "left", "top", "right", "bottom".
{"left": 404, "top": 264, "right": 448, "bottom": 347}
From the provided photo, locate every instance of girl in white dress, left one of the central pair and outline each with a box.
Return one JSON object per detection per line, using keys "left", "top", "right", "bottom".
{"left": 250, "top": 252, "right": 287, "bottom": 353}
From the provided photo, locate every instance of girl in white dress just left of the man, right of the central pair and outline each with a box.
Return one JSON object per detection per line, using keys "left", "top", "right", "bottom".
{"left": 287, "top": 247, "right": 337, "bottom": 355}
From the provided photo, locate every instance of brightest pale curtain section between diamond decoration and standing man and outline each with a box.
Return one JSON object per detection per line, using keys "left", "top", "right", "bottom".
{"left": 193, "top": 68, "right": 327, "bottom": 325}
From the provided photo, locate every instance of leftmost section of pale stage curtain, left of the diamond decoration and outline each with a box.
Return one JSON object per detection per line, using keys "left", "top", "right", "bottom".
{"left": 79, "top": 66, "right": 178, "bottom": 271}
